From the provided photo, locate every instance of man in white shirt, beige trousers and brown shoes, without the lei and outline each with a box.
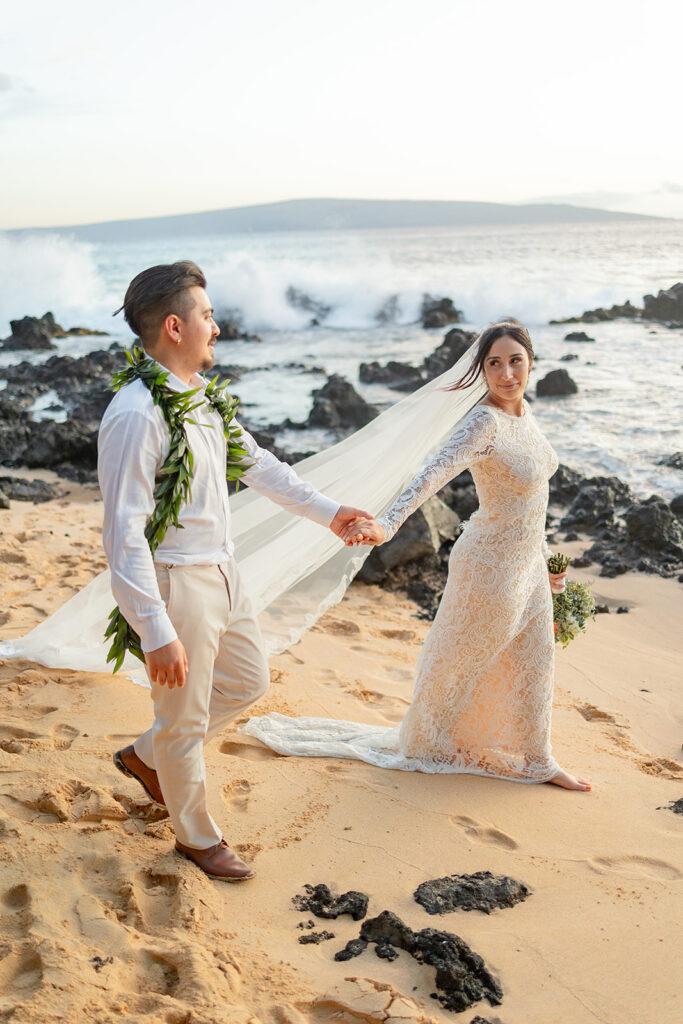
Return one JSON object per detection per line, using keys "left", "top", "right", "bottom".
{"left": 98, "top": 261, "right": 368, "bottom": 882}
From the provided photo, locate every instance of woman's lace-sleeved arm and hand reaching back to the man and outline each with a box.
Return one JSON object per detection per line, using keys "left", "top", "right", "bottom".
{"left": 344, "top": 406, "right": 496, "bottom": 544}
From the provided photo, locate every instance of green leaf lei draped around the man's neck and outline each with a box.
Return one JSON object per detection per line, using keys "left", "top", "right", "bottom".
{"left": 104, "top": 346, "right": 250, "bottom": 672}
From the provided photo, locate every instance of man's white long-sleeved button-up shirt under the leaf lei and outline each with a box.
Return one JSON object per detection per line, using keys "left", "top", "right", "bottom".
{"left": 97, "top": 364, "right": 340, "bottom": 651}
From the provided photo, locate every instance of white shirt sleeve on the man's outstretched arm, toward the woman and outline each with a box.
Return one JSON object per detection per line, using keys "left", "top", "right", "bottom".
{"left": 240, "top": 427, "right": 341, "bottom": 526}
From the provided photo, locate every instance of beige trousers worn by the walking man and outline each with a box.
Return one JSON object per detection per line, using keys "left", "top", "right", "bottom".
{"left": 133, "top": 559, "right": 269, "bottom": 849}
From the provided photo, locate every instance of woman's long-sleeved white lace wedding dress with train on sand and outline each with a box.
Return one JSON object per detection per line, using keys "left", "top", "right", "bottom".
{"left": 243, "top": 402, "right": 559, "bottom": 782}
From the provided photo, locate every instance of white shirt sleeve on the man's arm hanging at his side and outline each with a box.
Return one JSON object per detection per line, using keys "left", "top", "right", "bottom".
{"left": 97, "top": 407, "right": 177, "bottom": 652}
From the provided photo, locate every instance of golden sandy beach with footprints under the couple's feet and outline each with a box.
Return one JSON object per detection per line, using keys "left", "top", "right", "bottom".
{"left": 0, "top": 484, "right": 683, "bottom": 1024}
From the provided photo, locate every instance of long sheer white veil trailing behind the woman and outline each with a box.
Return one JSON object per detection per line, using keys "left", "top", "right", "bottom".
{"left": 0, "top": 350, "right": 485, "bottom": 685}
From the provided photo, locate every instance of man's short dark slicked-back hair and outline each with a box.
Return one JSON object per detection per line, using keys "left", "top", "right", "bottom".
{"left": 114, "top": 259, "right": 206, "bottom": 342}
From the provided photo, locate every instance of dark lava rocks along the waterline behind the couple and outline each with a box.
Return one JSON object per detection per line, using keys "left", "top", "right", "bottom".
{"left": 0, "top": 284, "right": 683, "bottom": 602}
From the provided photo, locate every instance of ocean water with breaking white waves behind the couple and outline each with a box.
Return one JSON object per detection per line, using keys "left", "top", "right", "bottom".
{"left": 0, "top": 221, "right": 683, "bottom": 497}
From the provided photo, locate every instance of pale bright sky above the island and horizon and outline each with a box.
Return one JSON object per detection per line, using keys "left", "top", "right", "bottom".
{"left": 0, "top": 0, "right": 683, "bottom": 229}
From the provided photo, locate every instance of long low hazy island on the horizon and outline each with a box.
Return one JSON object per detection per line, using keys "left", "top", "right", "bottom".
{"left": 12, "top": 193, "right": 656, "bottom": 242}
